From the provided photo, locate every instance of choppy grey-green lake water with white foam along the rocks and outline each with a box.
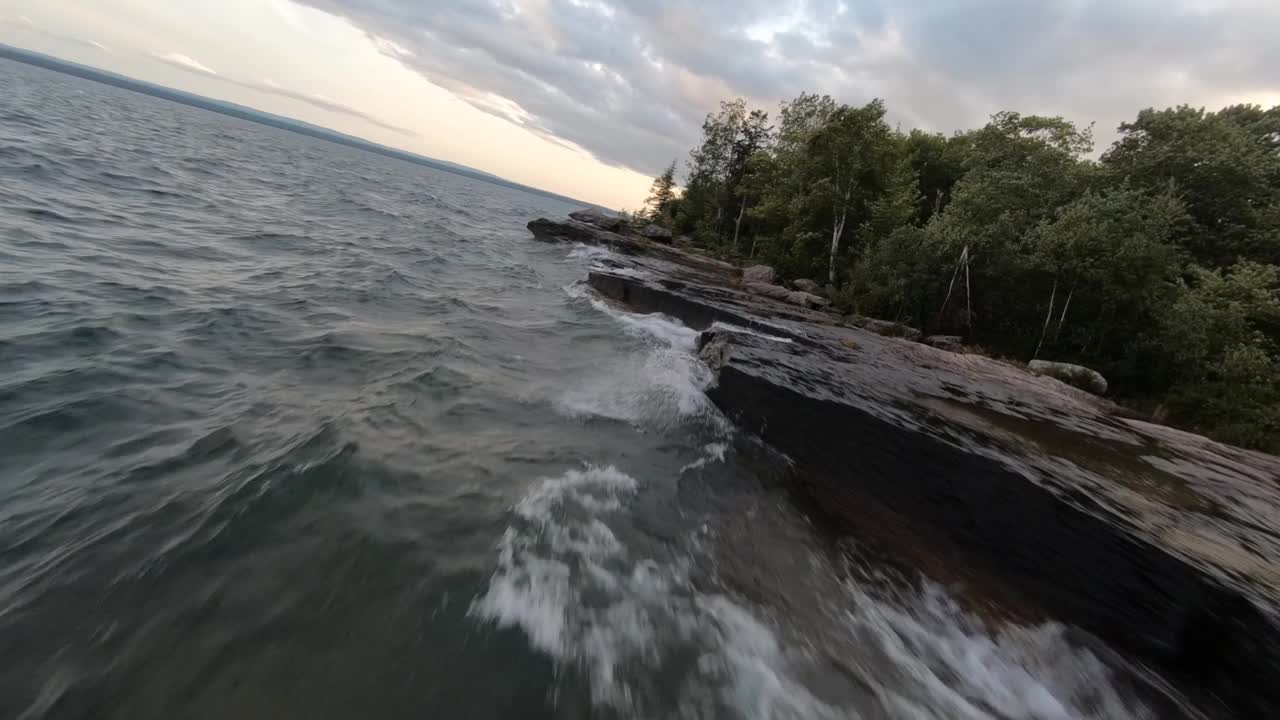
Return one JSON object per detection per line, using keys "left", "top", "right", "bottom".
{"left": 0, "top": 61, "right": 1177, "bottom": 720}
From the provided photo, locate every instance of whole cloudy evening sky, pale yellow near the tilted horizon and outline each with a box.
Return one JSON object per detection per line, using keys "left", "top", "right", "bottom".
{"left": 0, "top": 0, "right": 1280, "bottom": 209}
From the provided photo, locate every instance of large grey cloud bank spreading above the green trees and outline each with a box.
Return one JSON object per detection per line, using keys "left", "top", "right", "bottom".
{"left": 297, "top": 0, "right": 1280, "bottom": 174}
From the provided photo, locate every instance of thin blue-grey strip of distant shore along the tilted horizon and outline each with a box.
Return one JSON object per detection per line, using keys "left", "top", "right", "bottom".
{"left": 0, "top": 42, "right": 603, "bottom": 209}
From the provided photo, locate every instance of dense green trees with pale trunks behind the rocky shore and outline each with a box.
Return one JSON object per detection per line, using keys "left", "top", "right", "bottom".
{"left": 645, "top": 94, "right": 1280, "bottom": 451}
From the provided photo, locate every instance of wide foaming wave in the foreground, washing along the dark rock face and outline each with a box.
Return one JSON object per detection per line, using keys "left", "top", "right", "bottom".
{"left": 468, "top": 448, "right": 1172, "bottom": 720}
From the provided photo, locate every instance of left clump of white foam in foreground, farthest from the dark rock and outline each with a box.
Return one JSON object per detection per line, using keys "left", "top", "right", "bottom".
{"left": 470, "top": 466, "right": 844, "bottom": 720}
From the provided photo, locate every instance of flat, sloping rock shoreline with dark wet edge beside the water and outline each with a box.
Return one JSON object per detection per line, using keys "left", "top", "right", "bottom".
{"left": 529, "top": 214, "right": 1280, "bottom": 717}
